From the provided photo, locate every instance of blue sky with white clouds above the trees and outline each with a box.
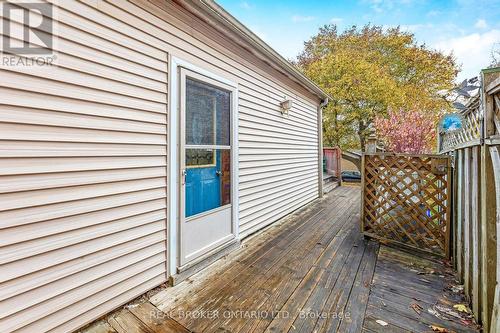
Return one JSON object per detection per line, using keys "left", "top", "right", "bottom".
{"left": 217, "top": 0, "right": 500, "bottom": 81}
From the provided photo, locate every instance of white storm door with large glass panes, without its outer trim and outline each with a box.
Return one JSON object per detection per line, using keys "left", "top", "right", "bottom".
{"left": 179, "top": 68, "right": 235, "bottom": 267}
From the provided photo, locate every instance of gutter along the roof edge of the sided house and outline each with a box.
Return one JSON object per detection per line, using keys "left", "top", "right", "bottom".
{"left": 196, "top": 0, "right": 329, "bottom": 99}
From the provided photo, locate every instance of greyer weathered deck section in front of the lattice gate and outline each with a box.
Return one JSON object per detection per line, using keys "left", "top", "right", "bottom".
{"left": 364, "top": 246, "right": 477, "bottom": 332}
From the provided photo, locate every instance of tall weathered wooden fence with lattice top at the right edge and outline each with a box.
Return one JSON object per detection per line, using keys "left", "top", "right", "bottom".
{"left": 439, "top": 68, "right": 500, "bottom": 333}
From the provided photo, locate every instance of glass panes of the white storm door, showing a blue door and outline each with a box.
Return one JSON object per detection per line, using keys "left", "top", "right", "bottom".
{"left": 184, "top": 78, "right": 231, "bottom": 217}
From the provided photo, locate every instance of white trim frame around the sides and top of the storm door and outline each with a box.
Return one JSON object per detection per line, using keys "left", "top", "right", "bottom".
{"left": 167, "top": 56, "right": 239, "bottom": 276}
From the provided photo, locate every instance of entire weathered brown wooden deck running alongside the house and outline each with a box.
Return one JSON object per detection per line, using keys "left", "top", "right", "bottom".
{"left": 86, "top": 187, "right": 473, "bottom": 333}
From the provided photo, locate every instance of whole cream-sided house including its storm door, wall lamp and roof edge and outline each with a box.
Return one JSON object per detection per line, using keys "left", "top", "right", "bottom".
{"left": 0, "top": 0, "right": 327, "bottom": 332}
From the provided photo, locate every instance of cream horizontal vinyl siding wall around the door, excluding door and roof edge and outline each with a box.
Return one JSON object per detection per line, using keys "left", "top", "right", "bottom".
{"left": 0, "top": 0, "right": 319, "bottom": 332}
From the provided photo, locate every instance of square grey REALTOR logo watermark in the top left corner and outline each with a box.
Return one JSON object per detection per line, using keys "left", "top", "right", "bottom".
{"left": 0, "top": 0, "right": 57, "bottom": 67}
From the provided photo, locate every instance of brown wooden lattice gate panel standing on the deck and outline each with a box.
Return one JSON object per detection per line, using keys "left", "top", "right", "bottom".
{"left": 361, "top": 153, "right": 452, "bottom": 257}
